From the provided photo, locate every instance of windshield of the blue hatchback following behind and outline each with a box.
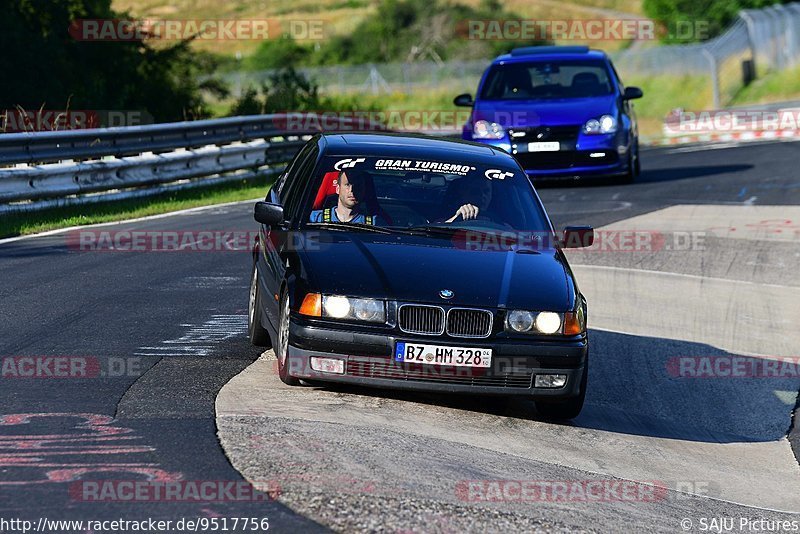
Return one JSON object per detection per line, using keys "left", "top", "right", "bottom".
{"left": 480, "top": 60, "right": 613, "bottom": 100}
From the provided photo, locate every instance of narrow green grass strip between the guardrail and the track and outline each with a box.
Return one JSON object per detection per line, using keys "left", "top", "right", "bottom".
{"left": 0, "top": 177, "right": 272, "bottom": 238}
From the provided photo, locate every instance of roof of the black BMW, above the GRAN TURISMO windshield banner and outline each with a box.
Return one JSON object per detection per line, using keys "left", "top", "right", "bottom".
{"left": 320, "top": 133, "right": 517, "bottom": 167}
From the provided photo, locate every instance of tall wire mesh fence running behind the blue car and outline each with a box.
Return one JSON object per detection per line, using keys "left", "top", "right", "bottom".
{"left": 223, "top": 2, "right": 800, "bottom": 108}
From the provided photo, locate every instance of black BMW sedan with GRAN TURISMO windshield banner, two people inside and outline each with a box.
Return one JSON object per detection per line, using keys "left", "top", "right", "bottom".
{"left": 249, "top": 133, "right": 593, "bottom": 419}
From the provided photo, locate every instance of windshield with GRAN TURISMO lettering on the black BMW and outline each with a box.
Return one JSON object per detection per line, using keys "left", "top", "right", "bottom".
{"left": 303, "top": 156, "right": 550, "bottom": 237}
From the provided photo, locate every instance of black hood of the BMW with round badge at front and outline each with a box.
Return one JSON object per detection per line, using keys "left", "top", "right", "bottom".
{"left": 301, "top": 232, "right": 574, "bottom": 311}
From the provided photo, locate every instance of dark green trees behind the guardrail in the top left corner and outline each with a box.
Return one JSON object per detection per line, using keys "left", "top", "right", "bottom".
{"left": 0, "top": 0, "right": 225, "bottom": 121}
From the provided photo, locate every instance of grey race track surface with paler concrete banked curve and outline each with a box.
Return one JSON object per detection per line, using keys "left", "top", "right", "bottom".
{"left": 0, "top": 142, "right": 800, "bottom": 532}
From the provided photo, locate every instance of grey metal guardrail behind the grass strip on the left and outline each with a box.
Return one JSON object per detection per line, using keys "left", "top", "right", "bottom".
{"left": 0, "top": 114, "right": 376, "bottom": 214}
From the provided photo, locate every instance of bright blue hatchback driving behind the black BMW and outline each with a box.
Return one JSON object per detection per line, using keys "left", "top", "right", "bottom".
{"left": 453, "top": 46, "right": 642, "bottom": 181}
